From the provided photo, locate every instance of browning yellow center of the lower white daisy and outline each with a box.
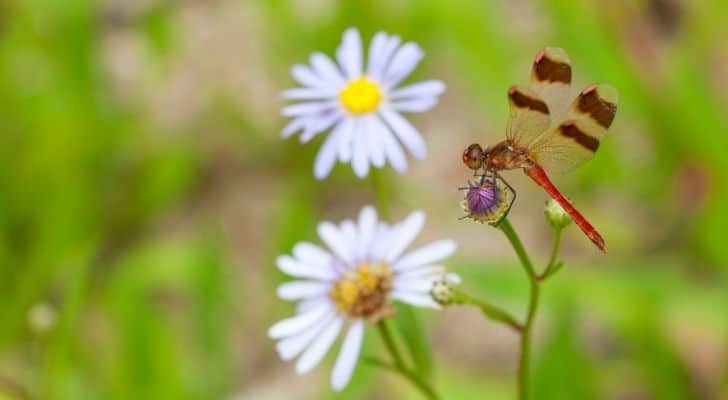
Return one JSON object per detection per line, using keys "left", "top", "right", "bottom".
{"left": 329, "top": 262, "right": 392, "bottom": 319}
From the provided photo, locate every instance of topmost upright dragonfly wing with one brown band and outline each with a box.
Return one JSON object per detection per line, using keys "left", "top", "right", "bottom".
{"left": 531, "top": 47, "right": 573, "bottom": 120}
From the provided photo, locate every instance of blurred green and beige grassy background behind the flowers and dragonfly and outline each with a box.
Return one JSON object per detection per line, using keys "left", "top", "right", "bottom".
{"left": 0, "top": 0, "right": 728, "bottom": 400}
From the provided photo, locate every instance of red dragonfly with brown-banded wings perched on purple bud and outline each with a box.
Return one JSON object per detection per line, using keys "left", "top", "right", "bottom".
{"left": 462, "top": 47, "right": 617, "bottom": 252}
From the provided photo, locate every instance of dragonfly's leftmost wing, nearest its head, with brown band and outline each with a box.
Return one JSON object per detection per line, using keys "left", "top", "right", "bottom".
{"left": 507, "top": 86, "right": 551, "bottom": 147}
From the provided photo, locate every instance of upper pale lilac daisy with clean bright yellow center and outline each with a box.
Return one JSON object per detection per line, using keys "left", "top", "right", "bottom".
{"left": 281, "top": 28, "right": 445, "bottom": 179}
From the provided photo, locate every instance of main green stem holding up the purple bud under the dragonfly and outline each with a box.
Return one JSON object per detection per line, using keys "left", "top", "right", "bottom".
{"left": 498, "top": 218, "right": 539, "bottom": 400}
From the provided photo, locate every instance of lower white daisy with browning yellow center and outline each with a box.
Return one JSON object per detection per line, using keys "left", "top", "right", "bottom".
{"left": 268, "top": 206, "right": 455, "bottom": 390}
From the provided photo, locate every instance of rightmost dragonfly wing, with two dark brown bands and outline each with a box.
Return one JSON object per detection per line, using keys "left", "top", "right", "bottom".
{"left": 529, "top": 85, "right": 617, "bottom": 172}
